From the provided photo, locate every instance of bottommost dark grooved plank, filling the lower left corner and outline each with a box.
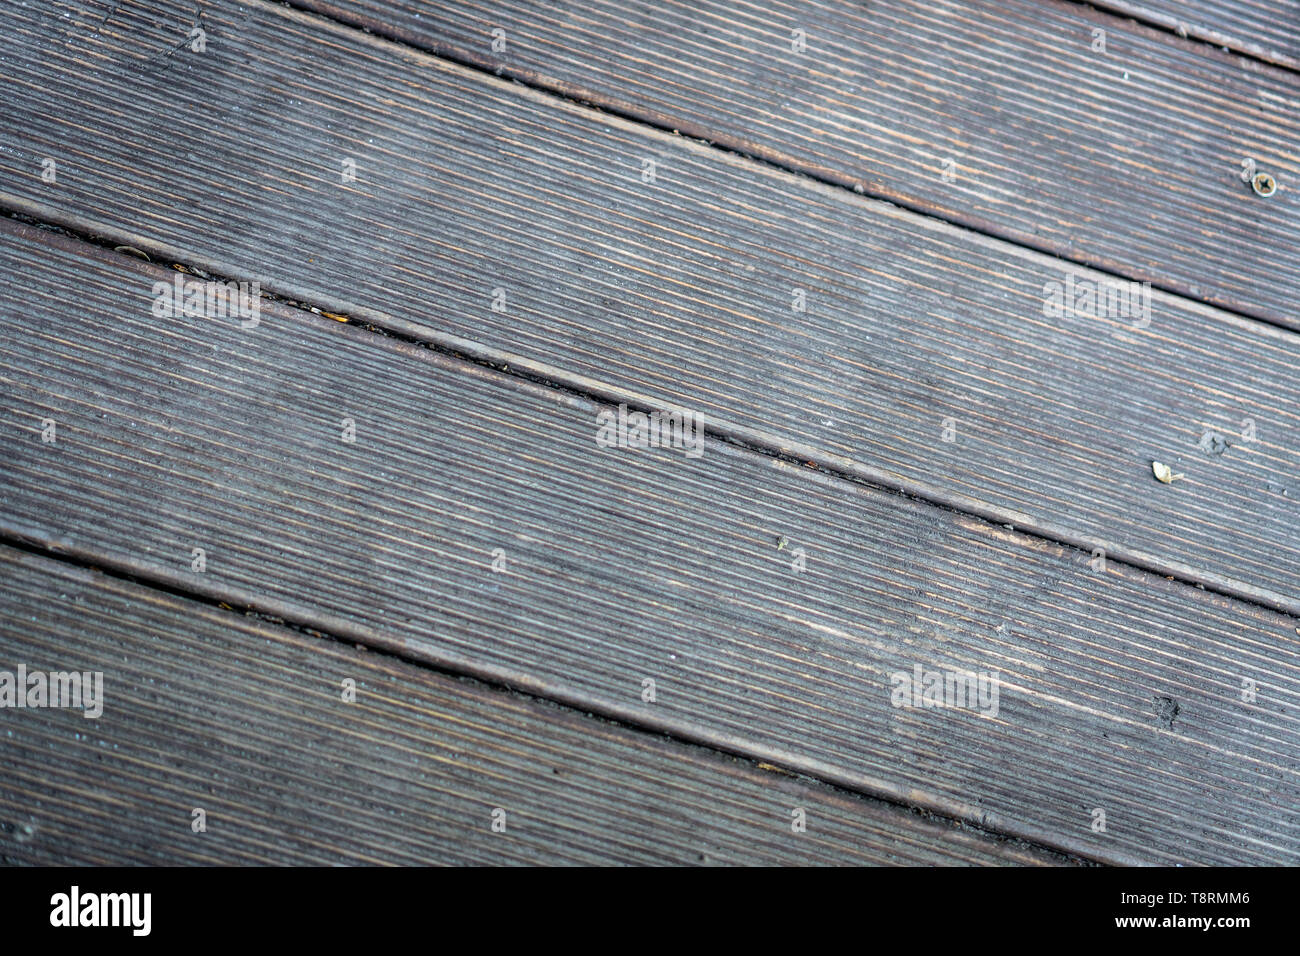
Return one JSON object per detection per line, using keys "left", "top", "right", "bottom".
{"left": 0, "top": 548, "right": 1067, "bottom": 865}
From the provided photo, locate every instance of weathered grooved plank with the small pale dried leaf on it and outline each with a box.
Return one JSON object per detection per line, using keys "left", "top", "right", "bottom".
{"left": 0, "top": 3, "right": 1300, "bottom": 611}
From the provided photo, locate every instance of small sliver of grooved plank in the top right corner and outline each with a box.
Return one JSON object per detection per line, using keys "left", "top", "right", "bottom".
{"left": 1096, "top": 0, "right": 1300, "bottom": 69}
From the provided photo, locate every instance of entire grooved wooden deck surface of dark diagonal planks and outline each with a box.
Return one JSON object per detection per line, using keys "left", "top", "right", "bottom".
{"left": 0, "top": 0, "right": 1300, "bottom": 865}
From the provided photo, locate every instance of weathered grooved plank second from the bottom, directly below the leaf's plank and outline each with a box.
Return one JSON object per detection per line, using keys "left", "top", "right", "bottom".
{"left": 0, "top": 224, "right": 1300, "bottom": 862}
